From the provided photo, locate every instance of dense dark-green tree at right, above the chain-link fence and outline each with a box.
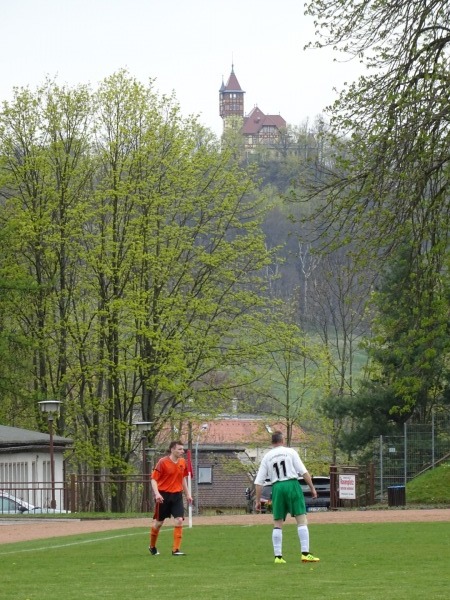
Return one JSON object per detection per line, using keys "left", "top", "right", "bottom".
{"left": 329, "top": 245, "right": 450, "bottom": 451}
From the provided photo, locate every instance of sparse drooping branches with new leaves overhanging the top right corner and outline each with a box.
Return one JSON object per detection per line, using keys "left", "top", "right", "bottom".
{"left": 308, "top": 0, "right": 450, "bottom": 250}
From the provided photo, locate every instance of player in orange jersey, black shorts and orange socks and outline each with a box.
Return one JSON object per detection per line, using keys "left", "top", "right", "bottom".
{"left": 149, "top": 440, "right": 192, "bottom": 556}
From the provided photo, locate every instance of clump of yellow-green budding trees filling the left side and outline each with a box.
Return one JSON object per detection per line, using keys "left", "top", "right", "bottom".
{"left": 0, "top": 71, "right": 278, "bottom": 471}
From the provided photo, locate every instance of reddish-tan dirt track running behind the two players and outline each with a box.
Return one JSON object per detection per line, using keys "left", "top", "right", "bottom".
{"left": 0, "top": 509, "right": 450, "bottom": 544}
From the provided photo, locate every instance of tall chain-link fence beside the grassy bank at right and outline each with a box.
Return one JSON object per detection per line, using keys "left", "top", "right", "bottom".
{"left": 373, "top": 411, "right": 450, "bottom": 501}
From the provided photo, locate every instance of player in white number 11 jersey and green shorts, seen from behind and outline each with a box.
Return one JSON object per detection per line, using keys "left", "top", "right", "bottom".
{"left": 255, "top": 431, "right": 319, "bottom": 564}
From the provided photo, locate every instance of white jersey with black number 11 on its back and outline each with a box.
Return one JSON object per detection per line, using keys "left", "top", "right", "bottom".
{"left": 255, "top": 446, "right": 307, "bottom": 485}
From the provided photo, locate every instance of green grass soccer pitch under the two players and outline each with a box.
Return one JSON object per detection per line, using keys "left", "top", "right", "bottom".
{"left": 0, "top": 522, "right": 450, "bottom": 600}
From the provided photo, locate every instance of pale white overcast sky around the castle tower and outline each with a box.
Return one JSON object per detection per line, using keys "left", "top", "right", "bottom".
{"left": 0, "top": 0, "right": 361, "bottom": 134}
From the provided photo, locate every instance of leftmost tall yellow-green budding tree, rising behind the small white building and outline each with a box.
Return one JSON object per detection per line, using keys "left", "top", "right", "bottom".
{"left": 0, "top": 82, "right": 89, "bottom": 426}
